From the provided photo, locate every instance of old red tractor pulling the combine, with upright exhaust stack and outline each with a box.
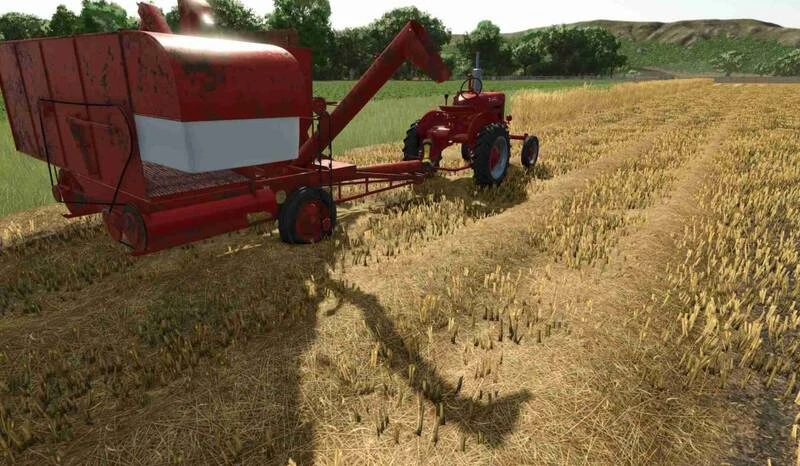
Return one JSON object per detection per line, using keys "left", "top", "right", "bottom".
{"left": 403, "top": 56, "right": 539, "bottom": 186}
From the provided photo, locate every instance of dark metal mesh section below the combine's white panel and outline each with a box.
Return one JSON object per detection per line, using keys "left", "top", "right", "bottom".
{"left": 142, "top": 161, "right": 249, "bottom": 197}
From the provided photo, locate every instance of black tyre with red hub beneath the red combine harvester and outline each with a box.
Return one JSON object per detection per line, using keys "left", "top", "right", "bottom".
{"left": 278, "top": 186, "right": 336, "bottom": 244}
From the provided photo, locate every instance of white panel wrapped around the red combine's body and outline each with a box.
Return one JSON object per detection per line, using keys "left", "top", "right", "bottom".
{"left": 134, "top": 115, "right": 300, "bottom": 173}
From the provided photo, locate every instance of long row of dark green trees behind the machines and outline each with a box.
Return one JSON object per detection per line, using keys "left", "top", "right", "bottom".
{"left": 0, "top": 0, "right": 626, "bottom": 79}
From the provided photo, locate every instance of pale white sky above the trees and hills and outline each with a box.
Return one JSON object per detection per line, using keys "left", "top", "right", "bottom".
{"left": 0, "top": 0, "right": 800, "bottom": 34}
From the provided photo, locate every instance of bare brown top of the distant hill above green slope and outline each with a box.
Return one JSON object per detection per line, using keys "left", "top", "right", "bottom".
{"left": 506, "top": 19, "right": 800, "bottom": 47}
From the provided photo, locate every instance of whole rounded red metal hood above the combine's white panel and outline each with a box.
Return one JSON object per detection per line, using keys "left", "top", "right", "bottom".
{"left": 123, "top": 31, "right": 311, "bottom": 121}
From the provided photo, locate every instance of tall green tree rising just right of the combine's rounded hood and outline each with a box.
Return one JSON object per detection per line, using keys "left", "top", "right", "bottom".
{"left": 267, "top": 0, "right": 334, "bottom": 78}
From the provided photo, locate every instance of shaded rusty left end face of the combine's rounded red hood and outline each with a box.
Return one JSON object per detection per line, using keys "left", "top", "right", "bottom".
{"left": 121, "top": 31, "right": 181, "bottom": 120}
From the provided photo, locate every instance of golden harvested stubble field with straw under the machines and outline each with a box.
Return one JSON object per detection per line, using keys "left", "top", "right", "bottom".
{"left": 0, "top": 80, "right": 800, "bottom": 465}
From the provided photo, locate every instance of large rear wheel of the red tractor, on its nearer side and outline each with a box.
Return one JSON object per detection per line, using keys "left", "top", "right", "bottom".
{"left": 472, "top": 123, "right": 511, "bottom": 186}
